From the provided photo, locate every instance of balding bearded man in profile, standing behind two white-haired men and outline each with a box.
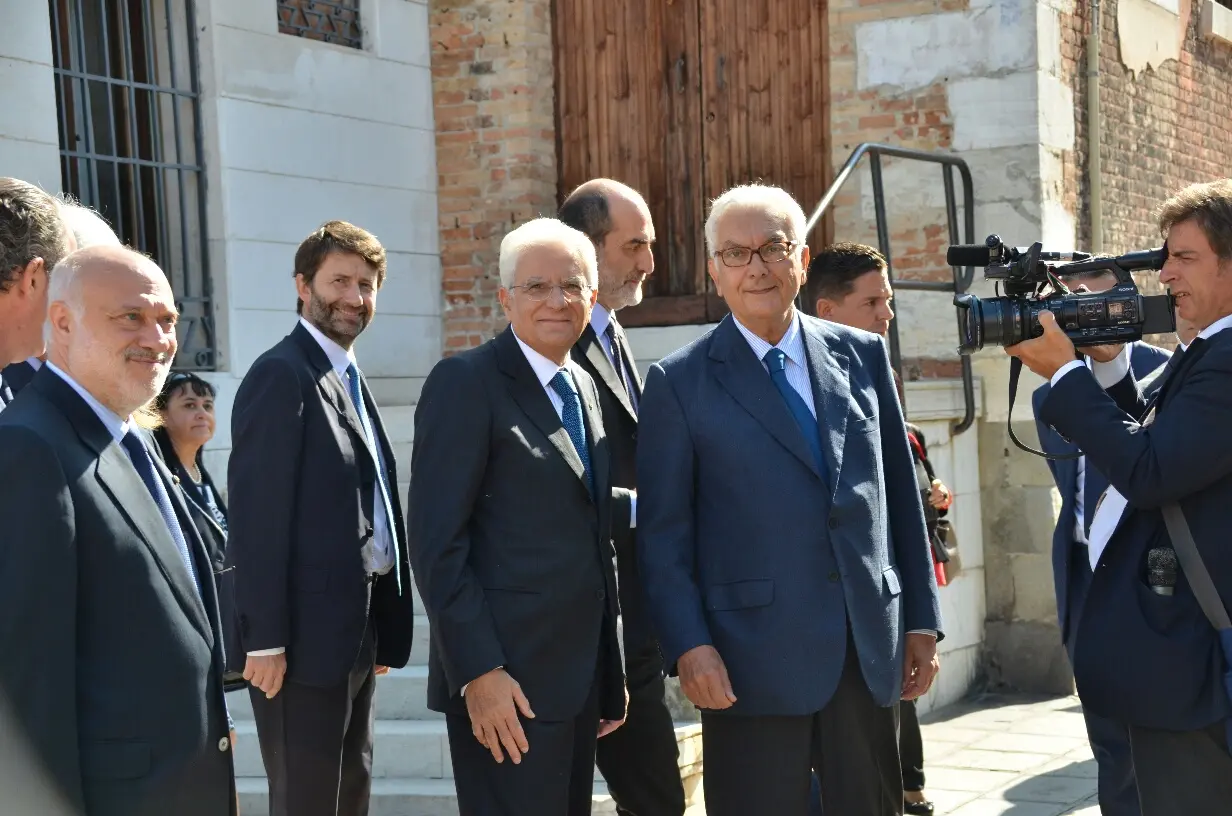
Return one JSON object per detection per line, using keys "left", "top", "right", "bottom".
{"left": 558, "top": 179, "right": 685, "bottom": 816}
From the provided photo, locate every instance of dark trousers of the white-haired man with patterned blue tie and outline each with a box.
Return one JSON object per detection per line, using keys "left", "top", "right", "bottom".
{"left": 446, "top": 683, "right": 599, "bottom": 816}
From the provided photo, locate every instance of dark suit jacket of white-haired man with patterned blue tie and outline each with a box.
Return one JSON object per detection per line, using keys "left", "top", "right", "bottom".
{"left": 408, "top": 329, "right": 625, "bottom": 721}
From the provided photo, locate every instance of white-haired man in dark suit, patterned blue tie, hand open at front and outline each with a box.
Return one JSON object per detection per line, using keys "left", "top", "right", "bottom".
{"left": 408, "top": 218, "right": 632, "bottom": 816}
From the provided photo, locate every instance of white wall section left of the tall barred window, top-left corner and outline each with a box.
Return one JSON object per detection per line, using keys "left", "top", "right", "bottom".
{"left": 0, "top": 0, "right": 60, "bottom": 192}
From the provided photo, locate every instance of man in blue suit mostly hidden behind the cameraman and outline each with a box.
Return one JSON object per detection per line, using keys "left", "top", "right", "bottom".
{"left": 1031, "top": 271, "right": 1172, "bottom": 816}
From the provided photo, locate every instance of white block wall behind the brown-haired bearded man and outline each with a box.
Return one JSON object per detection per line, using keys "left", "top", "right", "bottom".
{"left": 198, "top": 0, "right": 441, "bottom": 478}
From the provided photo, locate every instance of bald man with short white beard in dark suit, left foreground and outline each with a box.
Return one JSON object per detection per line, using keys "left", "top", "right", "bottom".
{"left": 0, "top": 248, "right": 235, "bottom": 816}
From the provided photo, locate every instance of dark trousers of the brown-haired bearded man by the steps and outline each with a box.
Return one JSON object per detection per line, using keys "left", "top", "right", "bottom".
{"left": 249, "top": 622, "right": 376, "bottom": 816}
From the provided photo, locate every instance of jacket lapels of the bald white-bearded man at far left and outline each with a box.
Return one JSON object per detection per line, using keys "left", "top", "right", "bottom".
{"left": 95, "top": 441, "right": 213, "bottom": 646}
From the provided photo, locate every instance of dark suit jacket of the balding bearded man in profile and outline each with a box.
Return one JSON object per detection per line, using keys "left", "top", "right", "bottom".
{"left": 573, "top": 323, "right": 663, "bottom": 687}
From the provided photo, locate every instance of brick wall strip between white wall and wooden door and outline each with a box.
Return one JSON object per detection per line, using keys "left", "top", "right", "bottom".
{"left": 431, "top": 0, "right": 557, "bottom": 355}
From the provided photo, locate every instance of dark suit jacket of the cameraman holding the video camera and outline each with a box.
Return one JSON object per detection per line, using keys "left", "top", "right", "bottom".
{"left": 1040, "top": 330, "right": 1232, "bottom": 731}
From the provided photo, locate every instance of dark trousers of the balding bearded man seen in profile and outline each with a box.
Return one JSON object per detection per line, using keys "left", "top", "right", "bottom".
{"left": 595, "top": 647, "right": 685, "bottom": 816}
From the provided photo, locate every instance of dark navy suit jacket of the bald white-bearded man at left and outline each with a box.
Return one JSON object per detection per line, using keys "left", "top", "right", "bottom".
{"left": 0, "top": 369, "right": 235, "bottom": 816}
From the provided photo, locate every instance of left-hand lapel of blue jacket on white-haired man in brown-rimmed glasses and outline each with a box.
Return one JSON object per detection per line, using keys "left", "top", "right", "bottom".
{"left": 710, "top": 316, "right": 821, "bottom": 478}
